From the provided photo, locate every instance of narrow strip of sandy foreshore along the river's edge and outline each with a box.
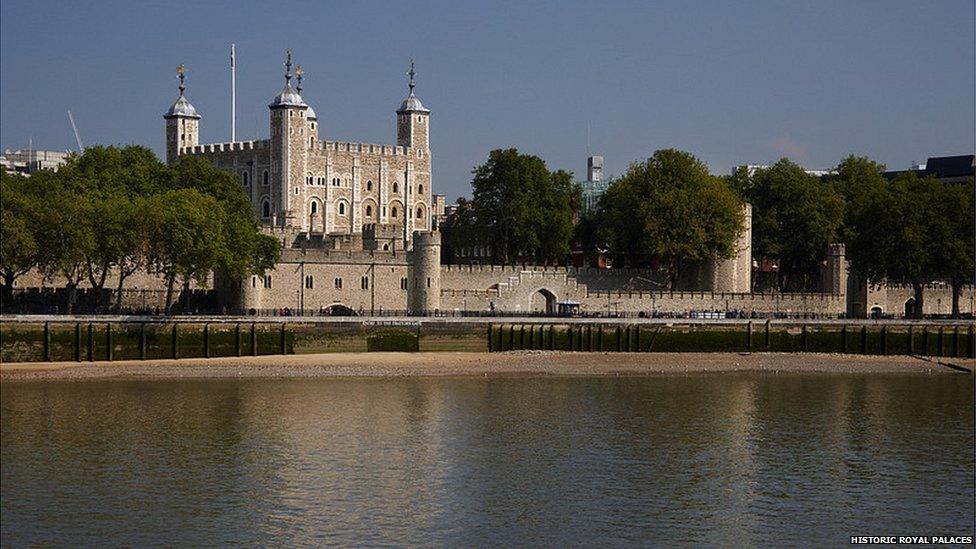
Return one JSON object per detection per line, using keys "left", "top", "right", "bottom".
{"left": 0, "top": 351, "right": 972, "bottom": 382}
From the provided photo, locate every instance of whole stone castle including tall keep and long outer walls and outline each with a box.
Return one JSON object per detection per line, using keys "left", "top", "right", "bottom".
{"left": 5, "top": 53, "right": 974, "bottom": 317}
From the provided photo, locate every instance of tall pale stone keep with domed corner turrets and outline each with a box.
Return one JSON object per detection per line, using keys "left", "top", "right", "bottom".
{"left": 163, "top": 52, "right": 432, "bottom": 248}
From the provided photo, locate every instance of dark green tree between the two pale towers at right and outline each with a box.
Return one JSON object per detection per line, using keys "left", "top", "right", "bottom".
{"left": 731, "top": 158, "right": 844, "bottom": 291}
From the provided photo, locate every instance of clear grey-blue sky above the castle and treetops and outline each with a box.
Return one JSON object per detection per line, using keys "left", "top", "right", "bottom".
{"left": 0, "top": 0, "right": 976, "bottom": 200}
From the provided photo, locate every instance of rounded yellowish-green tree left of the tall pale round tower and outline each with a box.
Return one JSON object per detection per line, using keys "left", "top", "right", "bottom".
{"left": 596, "top": 149, "right": 744, "bottom": 288}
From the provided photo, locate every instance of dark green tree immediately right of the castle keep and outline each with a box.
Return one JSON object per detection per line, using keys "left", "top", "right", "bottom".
{"left": 453, "top": 149, "right": 582, "bottom": 263}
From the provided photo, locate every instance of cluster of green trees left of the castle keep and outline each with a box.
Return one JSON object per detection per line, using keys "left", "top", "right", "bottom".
{"left": 0, "top": 146, "right": 280, "bottom": 310}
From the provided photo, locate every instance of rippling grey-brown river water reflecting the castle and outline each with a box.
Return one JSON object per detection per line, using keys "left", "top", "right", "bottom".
{"left": 0, "top": 374, "right": 974, "bottom": 547}
